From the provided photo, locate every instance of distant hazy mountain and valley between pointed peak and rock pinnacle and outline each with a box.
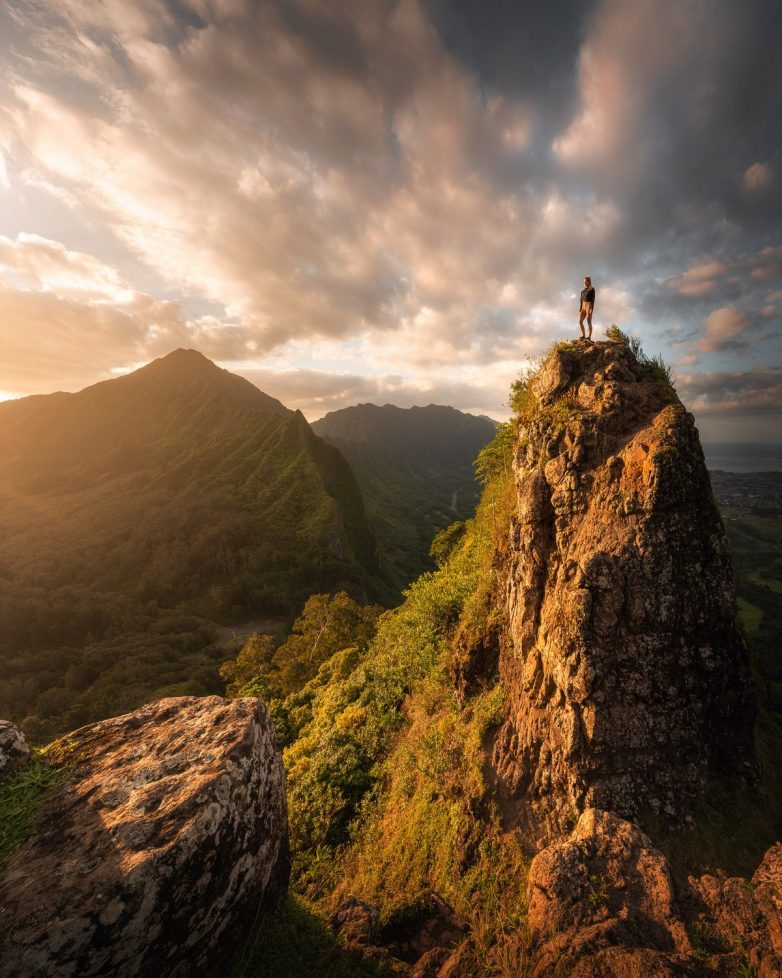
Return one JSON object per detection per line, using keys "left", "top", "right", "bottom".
{"left": 312, "top": 404, "right": 495, "bottom": 587}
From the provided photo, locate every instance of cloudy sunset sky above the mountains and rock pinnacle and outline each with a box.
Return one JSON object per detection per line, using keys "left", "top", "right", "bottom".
{"left": 0, "top": 0, "right": 782, "bottom": 442}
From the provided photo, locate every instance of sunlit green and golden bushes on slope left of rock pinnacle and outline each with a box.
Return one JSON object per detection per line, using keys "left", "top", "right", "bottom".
{"left": 225, "top": 414, "right": 526, "bottom": 975}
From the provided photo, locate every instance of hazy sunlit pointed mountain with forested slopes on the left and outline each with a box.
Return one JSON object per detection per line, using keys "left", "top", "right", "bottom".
{"left": 0, "top": 350, "right": 382, "bottom": 734}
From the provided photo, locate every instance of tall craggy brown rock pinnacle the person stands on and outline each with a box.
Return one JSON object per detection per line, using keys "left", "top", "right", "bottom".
{"left": 492, "top": 342, "right": 754, "bottom": 842}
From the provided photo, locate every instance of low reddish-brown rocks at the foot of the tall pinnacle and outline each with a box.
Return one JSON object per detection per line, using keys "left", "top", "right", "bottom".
{"left": 527, "top": 809, "right": 782, "bottom": 978}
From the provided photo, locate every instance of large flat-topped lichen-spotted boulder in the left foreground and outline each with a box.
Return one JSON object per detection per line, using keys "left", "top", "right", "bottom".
{"left": 0, "top": 696, "right": 288, "bottom": 978}
